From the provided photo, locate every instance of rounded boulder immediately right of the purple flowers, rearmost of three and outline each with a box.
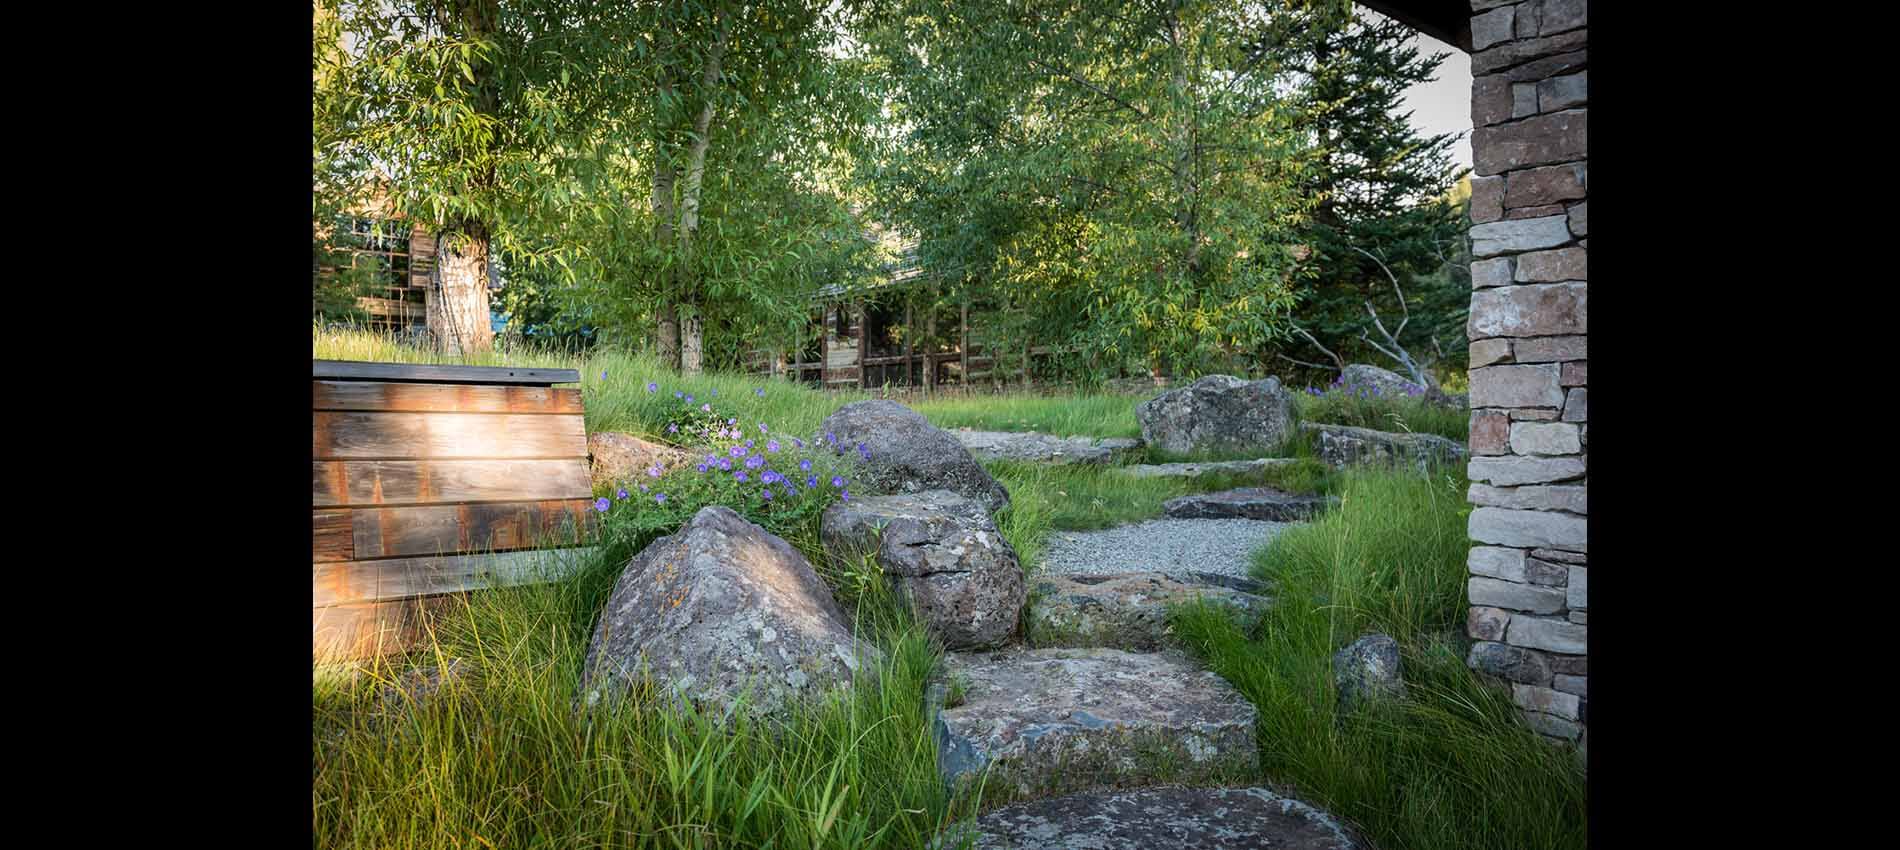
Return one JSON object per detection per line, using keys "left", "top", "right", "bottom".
{"left": 819, "top": 399, "right": 1009, "bottom": 512}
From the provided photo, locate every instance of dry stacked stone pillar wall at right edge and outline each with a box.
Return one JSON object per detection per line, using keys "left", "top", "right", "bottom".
{"left": 1467, "top": 0, "right": 1590, "bottom": 742}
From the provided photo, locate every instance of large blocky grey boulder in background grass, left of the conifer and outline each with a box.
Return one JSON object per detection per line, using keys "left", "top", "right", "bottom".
{"left": 1134, "top": 375, "right": 1294, "bottom": 453}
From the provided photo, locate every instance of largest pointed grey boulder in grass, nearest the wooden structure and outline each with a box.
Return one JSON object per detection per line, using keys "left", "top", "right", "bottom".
{"left": 581, "top": 506, "right": 880, "bottom": 715}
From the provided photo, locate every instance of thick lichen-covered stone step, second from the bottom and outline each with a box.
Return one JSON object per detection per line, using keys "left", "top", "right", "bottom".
{"left": 931, "top": 648, "right": 1260, "bottom": 802}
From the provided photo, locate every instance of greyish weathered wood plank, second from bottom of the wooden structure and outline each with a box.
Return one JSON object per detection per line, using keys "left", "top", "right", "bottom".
{"left": 310, "top": 548, "right": 593, "bottom": 609}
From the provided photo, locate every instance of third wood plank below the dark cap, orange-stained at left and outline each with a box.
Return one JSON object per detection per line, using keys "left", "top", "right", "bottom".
{"left": 310, "top": 458, "right": 593, "bottom": 508}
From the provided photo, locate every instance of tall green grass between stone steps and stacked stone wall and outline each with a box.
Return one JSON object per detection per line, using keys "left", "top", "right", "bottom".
{"left": 1174, "top": 472, "right": 1588, "bottom": 850}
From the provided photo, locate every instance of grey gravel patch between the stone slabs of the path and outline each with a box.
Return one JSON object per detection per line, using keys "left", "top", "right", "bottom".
{"left": 1041, "top": 519, "right": 1294, "bottom": 578}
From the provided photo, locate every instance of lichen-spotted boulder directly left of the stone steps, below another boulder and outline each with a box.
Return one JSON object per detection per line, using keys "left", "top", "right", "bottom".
{"left": 819, "top": 491, "right": 1028, "bottom": 648}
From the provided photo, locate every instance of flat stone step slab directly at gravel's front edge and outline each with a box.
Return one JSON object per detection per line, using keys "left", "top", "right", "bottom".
{"left": 1028, "top": 572, "right": 1269, "bottom": 652}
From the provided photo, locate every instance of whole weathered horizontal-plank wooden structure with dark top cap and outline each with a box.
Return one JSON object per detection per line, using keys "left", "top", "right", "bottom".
{"left": 310, "top": 359, "right": 595, "bottom": 660}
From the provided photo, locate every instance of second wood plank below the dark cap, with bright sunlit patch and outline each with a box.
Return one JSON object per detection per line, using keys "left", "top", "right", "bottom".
{"left": 310, "top": 411, "right": 587, "bottom": 460}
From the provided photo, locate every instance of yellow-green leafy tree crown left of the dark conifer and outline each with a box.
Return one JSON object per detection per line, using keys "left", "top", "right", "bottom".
{"left": 865, "top": 0, "right": 1313, "bottom": 380}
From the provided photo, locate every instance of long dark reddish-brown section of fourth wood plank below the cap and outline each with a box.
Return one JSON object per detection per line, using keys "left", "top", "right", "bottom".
{"left": 349, "top": 498, "right": 599, "bottom": 561}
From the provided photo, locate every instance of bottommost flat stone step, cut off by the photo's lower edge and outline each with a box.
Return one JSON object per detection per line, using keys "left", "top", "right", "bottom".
{"left": 975, "top": 787, "right": 1364, "bottom": 850}
